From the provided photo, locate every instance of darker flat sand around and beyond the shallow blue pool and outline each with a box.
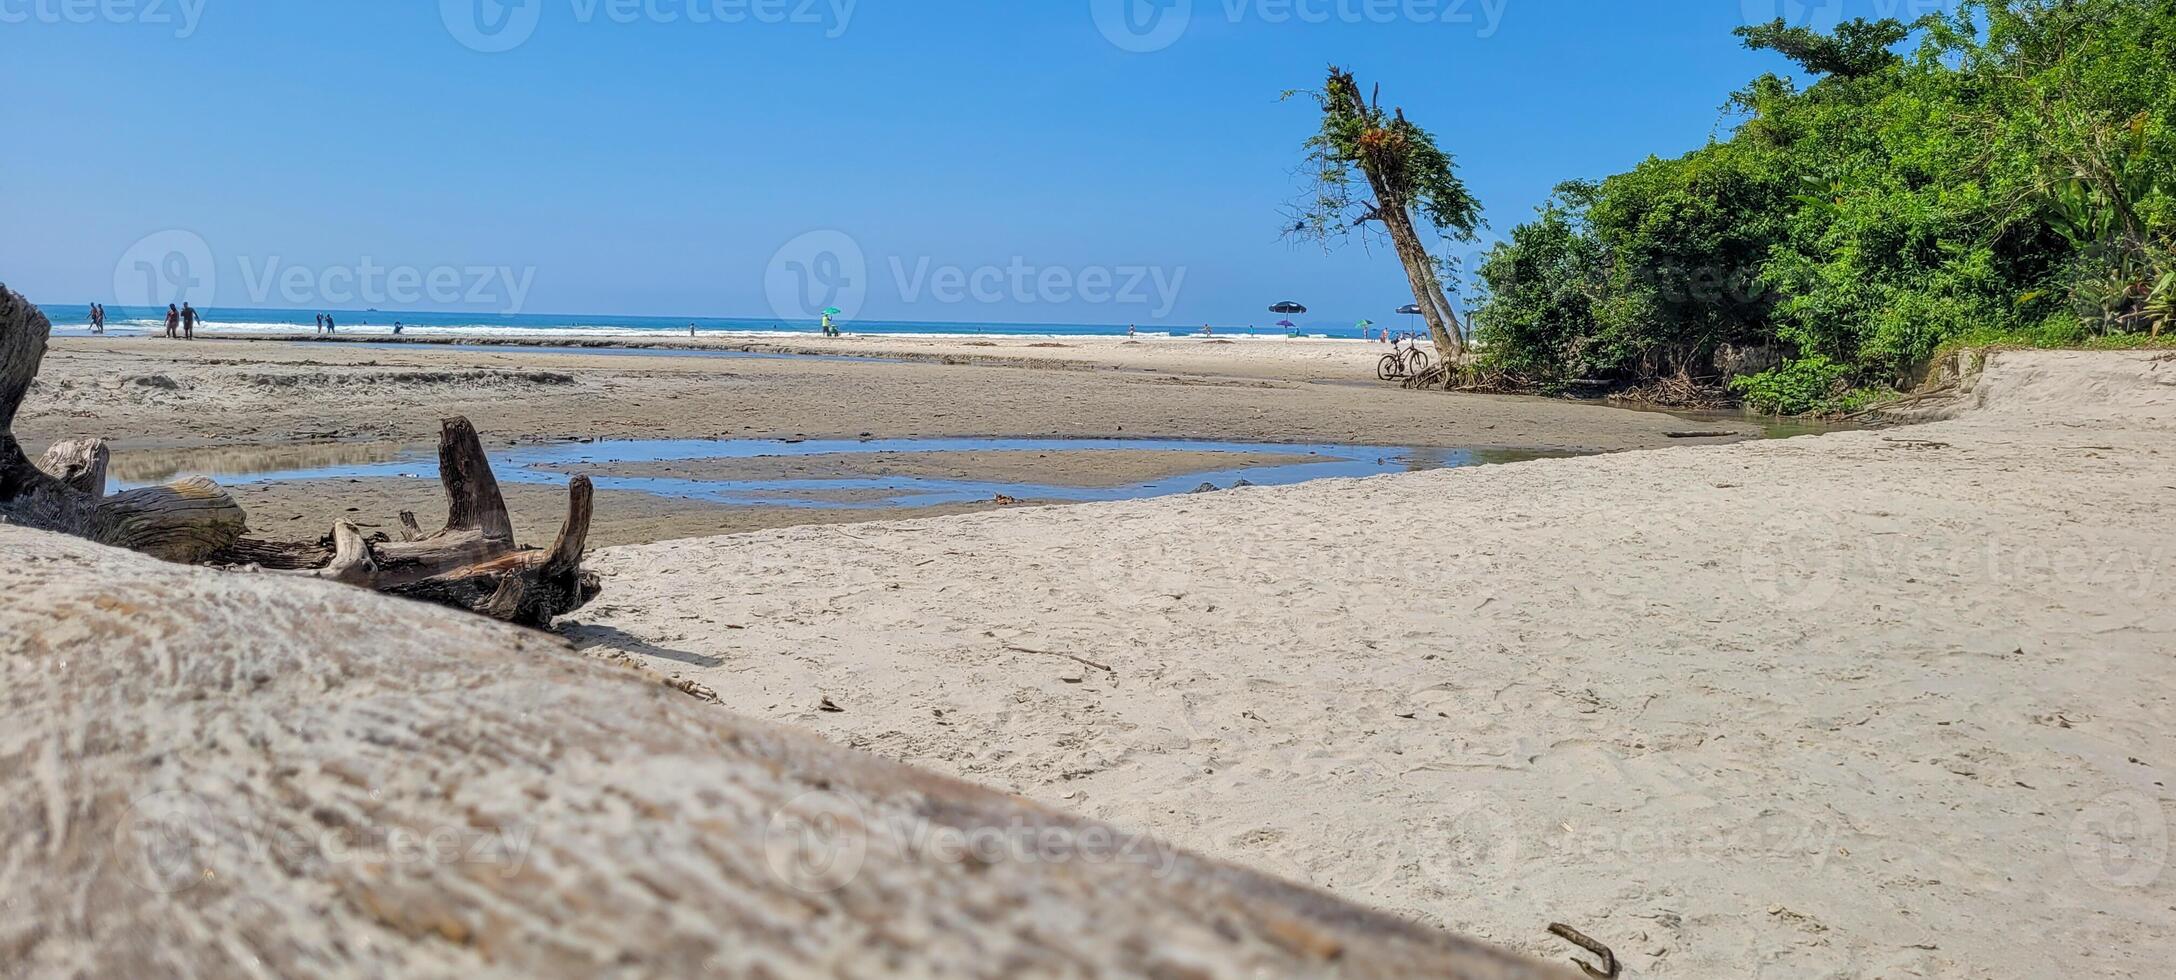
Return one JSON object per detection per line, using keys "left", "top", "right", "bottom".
{"left": 15, "top": 338, "right": 1760, "bottom": 542}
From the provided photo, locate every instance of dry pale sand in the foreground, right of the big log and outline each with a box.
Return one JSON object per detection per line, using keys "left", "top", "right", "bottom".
{"left": 581, "top": 353, "right": 2176, "bottom": 978}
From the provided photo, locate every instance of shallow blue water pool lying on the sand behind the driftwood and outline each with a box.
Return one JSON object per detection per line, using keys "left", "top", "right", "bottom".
{"left": 119, "top": 438, "right": 1567, "bottom": 510}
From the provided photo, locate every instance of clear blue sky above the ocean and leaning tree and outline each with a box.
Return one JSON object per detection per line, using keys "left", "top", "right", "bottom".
{"left": 0, "top": 0, "right": 1967, "bottom": 324}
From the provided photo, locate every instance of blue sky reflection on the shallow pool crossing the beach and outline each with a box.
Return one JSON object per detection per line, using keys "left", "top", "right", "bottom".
{"left": 122, "top": 438, "right": 1573, "bottom": 510}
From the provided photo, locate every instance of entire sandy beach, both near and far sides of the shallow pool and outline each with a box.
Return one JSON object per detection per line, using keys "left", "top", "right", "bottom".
{"left": 17, "top": 326, "right": 2176, "bottom": 978}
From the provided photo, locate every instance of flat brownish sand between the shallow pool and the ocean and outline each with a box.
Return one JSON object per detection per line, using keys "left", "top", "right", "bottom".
{"left": 15, "top": 338, "right": 1760, "bottom": 451}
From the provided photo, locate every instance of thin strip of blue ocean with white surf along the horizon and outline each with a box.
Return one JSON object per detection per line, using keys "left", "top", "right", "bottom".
{"left": 39, "top": 305, "right": 1358, "bottom": 340}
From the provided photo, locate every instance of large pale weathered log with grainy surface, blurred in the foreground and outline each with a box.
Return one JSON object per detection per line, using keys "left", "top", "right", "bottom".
{"left": 0, "top": 527, "right": 1573, "bottom": 980}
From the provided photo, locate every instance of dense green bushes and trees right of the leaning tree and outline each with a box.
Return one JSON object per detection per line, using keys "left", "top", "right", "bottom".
{"left": 1475, "top": 0, "right": 2176, "bottom": 414}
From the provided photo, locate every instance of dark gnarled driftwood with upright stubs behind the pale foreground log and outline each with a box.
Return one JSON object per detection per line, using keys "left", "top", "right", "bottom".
{"left": 0, "top": 285, "right": 598, "bottom": 629}
